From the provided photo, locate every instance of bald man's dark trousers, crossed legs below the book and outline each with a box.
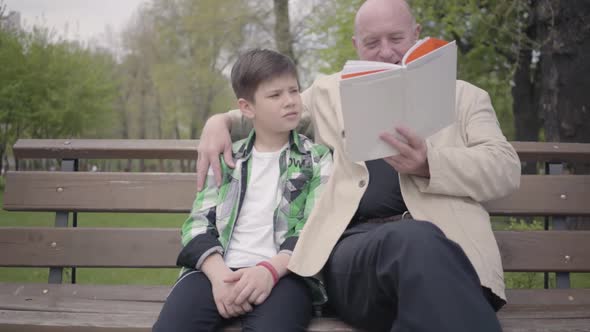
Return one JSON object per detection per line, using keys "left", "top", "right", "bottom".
{"left": 324, "top": 220, "right": 501, "bottom": 332}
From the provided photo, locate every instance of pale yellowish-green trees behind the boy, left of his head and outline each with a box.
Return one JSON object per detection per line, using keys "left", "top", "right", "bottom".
{"left": 112, "top": 0, "right": 251, "bottom": 138}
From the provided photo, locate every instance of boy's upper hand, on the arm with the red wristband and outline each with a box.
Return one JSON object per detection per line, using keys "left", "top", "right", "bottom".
{"left": 223, "top": 266, "right": 274, "bottom": 305}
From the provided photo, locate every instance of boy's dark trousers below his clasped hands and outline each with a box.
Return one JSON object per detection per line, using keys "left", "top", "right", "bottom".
{"left": 153, "top": 271, "right": 312, "bottom": 332}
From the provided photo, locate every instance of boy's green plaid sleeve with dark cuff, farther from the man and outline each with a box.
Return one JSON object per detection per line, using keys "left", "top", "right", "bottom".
{"left": 176, "top": 168, "right": 223, "bottom": 270}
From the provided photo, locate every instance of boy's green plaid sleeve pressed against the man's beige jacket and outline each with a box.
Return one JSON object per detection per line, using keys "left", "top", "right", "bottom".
{"left": 279, "top": 144, "right": 332, "bottom": 255}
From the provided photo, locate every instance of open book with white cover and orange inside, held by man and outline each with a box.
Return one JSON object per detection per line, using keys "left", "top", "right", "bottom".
{"left": 340, "top": 37, "right": 457, "bottom": 161}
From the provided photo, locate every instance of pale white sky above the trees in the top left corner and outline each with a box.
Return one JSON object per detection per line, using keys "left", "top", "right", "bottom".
{"left": 0, "top": 0, "right": 145, "bottom": 42}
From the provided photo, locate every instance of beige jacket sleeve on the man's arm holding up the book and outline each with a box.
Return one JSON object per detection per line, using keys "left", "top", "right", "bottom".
{"left": 412, "top": 83, "right": 520, "bottom": 202}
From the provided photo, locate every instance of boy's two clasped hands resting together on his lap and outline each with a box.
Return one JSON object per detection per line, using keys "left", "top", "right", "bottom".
{"left": 212, "top": 266, "right": 274, "bottom": 318}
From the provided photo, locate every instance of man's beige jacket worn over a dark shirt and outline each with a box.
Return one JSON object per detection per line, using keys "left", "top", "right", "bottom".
{"left": 229, "top": 74, "right": 520, "bottom": 299}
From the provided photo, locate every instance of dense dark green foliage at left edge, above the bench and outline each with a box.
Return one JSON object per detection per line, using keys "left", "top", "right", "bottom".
{"left": 0, "top": 28, "right": 117, "bottom": 165}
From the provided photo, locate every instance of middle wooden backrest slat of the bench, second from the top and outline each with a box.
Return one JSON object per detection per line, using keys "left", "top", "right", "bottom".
{"left": 4, "top": 172, "right": 590, "bottom": 216}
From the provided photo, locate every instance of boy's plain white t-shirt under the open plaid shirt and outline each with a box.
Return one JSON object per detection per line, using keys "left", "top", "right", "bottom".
{"left": 224, "top": 146, "right": 286, "bottom": 268}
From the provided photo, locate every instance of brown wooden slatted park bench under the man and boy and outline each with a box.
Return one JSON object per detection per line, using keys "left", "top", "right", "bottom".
{"left": 0, "top": 140, "right": 590, "bottom": 332}
